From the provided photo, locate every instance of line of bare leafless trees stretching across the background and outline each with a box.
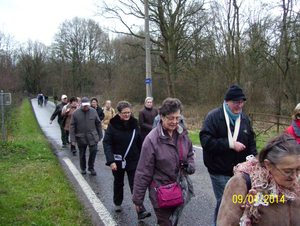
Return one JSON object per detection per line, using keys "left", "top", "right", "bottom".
{"left": 0, "top": 0, "right": 300, "bottom": 114}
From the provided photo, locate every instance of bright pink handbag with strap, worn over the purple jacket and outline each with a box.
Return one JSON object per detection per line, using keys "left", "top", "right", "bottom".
{"left": 152, "top": 137, "right": 184, "bottom": 209}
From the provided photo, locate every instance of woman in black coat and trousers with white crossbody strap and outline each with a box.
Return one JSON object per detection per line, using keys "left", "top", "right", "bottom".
{"left": 103, "top": 101, "right": 151, "bottom": 220}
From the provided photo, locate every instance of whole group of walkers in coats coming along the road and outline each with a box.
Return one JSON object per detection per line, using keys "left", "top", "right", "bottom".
{"left": 45, "top": 85, "right": 300, "bottom": 226}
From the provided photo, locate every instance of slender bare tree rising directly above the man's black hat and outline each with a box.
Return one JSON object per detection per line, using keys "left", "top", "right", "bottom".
{"left": 211, "top": 0, "right": 247, "bottom": 84}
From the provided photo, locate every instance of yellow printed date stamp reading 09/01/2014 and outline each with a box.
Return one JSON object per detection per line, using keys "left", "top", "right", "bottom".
{"left": 232, "top": 194, "right": 285, "bottom": 204}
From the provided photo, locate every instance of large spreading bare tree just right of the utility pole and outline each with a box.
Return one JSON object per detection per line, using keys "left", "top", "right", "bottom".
{"left": 98, "top": 0, "right": 204, "bottom": 96}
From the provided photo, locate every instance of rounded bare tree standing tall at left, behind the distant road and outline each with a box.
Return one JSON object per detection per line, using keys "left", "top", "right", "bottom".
{"left": 52, "top": 17, "right": 105, "bottom": 93}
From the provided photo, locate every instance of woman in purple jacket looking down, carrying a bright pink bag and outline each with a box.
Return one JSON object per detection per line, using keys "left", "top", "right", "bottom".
{"left": 132, "top": 98, "right": 195, "bottom": 226}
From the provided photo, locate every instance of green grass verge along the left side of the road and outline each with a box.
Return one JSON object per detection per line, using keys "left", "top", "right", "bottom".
{"left": 0, "top": 99, "right": 92, "bottom": 226}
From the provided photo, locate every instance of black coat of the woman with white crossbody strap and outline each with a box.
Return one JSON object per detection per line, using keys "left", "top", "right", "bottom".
{"left": 103, "top": 115, "right": 143, "bottom": 170}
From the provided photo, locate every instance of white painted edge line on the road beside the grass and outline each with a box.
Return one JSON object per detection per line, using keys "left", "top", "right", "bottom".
{"left": 63, "top": 157, "right": 117, "bottom": 226}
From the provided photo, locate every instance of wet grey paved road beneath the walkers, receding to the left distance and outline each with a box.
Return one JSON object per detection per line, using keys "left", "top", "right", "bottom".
{"left": 31, "top": 98, "right": 215, "bottom": 226}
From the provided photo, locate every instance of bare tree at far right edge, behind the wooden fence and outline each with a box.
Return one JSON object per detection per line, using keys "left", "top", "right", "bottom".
{"left": 258, "top": 0, "right": 300, "bottom": 114}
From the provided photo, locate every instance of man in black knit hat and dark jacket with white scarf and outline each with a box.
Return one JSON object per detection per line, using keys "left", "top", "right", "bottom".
{"left": 199, "top": 85, "right": 257, "bottom": 224}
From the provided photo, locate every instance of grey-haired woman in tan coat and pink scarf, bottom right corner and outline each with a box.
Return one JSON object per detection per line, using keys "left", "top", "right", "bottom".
{"left": 217, "top": 134, "right": 300, "bottom": 226}
